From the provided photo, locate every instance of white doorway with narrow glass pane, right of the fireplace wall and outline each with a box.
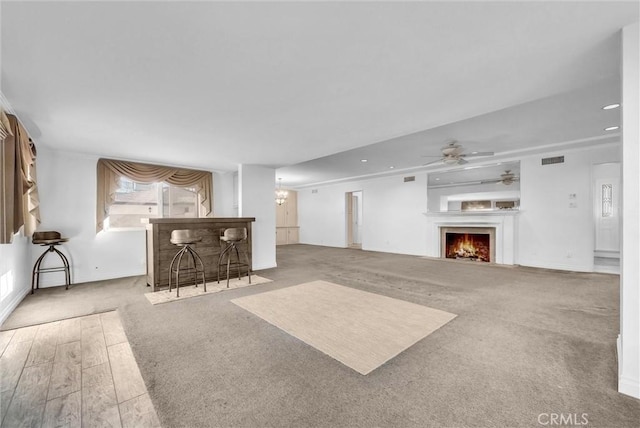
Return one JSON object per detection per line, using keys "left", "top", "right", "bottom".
{"left": 593, "top": 162, "right": 621, "bottom": 273}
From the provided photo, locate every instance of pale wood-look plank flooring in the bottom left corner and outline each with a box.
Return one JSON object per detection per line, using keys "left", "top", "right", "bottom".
{"left": 0, "top": 311, "right": 160, "bottom": 428}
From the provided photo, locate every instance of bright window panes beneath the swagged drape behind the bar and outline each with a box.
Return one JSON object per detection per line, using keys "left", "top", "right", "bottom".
{"left": 106, "top": 177, "right": 198, "bottom": 228}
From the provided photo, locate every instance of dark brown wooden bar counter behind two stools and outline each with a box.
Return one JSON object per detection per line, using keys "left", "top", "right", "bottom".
{"left": 142, "top": 217, "right": 256, "bottom": 291}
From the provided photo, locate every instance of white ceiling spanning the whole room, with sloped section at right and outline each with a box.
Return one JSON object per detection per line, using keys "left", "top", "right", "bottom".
{"left": 0, "top": 1, "right": 638, "bottom": 186}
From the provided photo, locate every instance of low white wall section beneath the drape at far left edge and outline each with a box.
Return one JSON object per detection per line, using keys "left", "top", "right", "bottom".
{"left": 0, "top": 234, "right": 31, "bottom": 324}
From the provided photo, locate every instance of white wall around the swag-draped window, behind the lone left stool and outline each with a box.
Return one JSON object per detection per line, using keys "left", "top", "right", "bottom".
{"left": 27, "top": 148, "right": 233, "bottom": 287}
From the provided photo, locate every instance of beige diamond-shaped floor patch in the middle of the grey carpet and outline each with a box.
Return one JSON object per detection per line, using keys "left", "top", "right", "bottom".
{"left": 231, "top": 281, "right": 456, "bottom": 375}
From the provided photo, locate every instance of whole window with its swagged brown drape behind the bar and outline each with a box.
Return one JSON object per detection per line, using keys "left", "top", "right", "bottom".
{"left": 96, "top": 159, "right": 213, "bottom": 232}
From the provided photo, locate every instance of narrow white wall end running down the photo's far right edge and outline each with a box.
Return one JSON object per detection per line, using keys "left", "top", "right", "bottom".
{"left": 618, "top": 23, "right": 640, "bottom": 398}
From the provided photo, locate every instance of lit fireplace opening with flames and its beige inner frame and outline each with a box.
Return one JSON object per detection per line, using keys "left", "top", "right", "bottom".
{"left": 440, "top": 227, "right": 496, "bottom": 263}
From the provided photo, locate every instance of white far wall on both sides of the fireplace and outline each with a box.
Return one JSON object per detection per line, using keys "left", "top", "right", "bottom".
{"left": 298, "top": 144, "right": 621, "bottom": 272}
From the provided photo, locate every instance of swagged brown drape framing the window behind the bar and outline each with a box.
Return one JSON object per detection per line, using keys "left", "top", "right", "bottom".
{"left": 96, "top": 159, "right": 213, "bottom": 232}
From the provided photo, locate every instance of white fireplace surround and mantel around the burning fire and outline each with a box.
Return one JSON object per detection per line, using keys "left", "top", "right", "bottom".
{"left": 425, "top": 210, "right": 519, "bottom": 265}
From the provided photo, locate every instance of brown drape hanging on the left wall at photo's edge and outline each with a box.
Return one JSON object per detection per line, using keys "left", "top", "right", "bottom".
{"left": 0, "top": 112, "right": 40, "bottom": 244}
